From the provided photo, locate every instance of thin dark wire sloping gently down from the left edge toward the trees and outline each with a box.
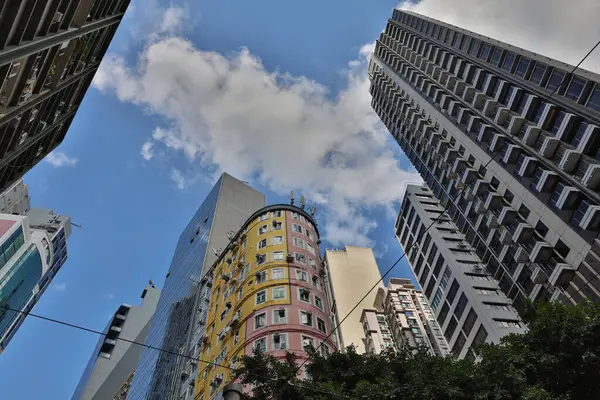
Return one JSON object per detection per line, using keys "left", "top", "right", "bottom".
{"left": 0, "top": 306, "right": 356, "bottom": 400}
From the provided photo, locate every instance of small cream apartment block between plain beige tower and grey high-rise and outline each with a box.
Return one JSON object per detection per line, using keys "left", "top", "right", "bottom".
{"left": 360, "top": 278, "right": 449, "bottom": 357}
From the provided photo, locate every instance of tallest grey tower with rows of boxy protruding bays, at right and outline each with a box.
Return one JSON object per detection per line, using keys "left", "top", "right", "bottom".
{"left": 369, "top": 10, "right": 600, "bottom": 308}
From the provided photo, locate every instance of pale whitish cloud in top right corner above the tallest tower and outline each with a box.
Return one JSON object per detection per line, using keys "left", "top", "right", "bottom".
{"left": 399, "top": 0, "right": 600, "bottom": 72}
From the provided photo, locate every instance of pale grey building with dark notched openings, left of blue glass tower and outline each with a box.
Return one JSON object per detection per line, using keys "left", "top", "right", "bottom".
{"left": 72, "top": 283, "right": 160, "bottom": 400}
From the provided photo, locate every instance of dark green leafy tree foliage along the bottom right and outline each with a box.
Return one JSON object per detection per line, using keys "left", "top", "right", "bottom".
{"left": 237, "top": 303, "right": 600, "bottom": 400}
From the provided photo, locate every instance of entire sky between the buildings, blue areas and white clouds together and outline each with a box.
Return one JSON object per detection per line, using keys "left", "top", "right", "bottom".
{"left": 0, "top": 0, "right": 600, "bottom": 400}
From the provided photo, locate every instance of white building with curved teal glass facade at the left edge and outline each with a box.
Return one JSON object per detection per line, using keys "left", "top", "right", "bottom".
{"left": 0, "top": 208, "right": 71, "bottom": 352}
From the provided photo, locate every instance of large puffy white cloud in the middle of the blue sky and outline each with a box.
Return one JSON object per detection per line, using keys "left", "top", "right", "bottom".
{"left": 94, "top": 38, "right": 421, "bottom": 245}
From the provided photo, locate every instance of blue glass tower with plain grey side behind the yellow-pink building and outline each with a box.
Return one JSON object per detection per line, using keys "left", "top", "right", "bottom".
{"left": 128, "top": 174, "right": 265, "bottom": 400}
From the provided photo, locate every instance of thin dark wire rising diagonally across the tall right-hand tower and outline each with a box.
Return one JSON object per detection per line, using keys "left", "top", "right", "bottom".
{"left": 300, "top": 35, "right": 600, "bottom": 367}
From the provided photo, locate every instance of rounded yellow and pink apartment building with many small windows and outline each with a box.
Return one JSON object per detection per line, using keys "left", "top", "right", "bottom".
{"left": 194, "top": 204, "right": 337, "bottom": 400}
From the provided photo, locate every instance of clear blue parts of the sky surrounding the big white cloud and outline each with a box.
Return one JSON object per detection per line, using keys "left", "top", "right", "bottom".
{"left": 0, "top": 0, "right": 418, "bottom": 400}
